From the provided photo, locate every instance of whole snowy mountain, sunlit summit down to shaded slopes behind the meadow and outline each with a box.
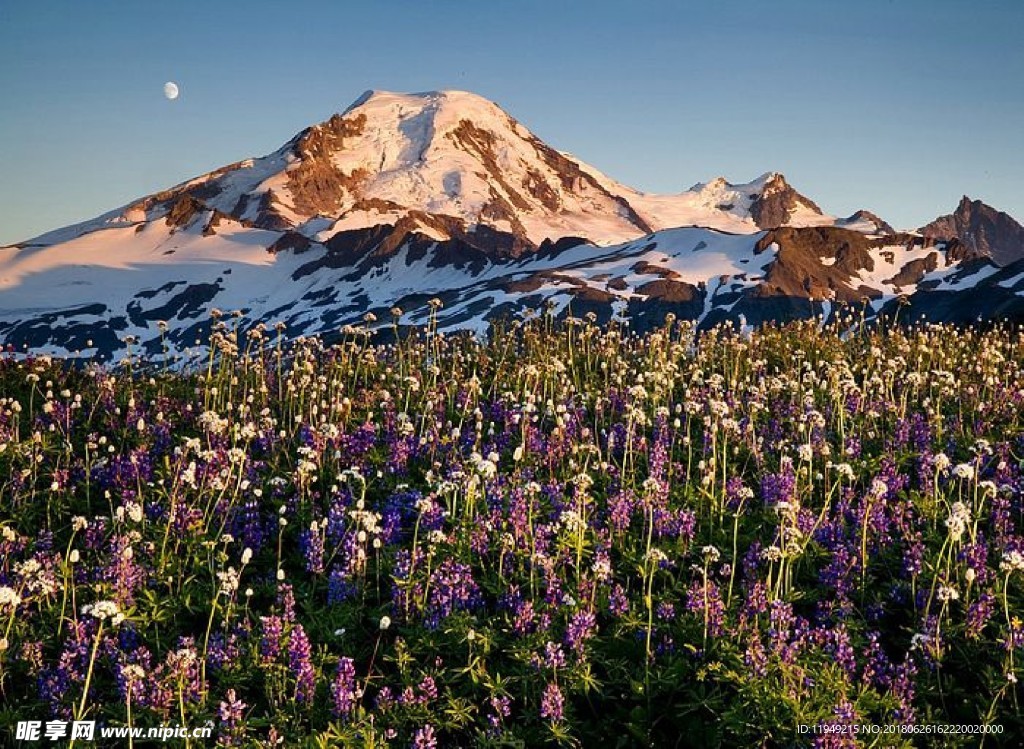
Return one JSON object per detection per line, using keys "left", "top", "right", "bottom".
{"left": 0, "top": 91, "right": 1024, "bottom": 356}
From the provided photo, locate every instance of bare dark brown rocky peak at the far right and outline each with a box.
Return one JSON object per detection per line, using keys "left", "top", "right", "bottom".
{"left": 920, "top": 196, "right": 1024, "bottom": 265}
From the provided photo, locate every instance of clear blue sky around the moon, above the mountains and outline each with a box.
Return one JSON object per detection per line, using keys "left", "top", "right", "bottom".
{"left": 0, "top": 0, "right": 1024, "bottom": 244}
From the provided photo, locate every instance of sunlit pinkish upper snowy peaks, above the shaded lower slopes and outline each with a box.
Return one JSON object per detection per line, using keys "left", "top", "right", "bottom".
{"left": 16, "top": 91, "right": 847, "bottom": 254}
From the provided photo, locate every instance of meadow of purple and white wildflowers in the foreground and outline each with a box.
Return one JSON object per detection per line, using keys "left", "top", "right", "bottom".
{"left": 0, "top": 309, "right": 1024, "bottom": 749}
